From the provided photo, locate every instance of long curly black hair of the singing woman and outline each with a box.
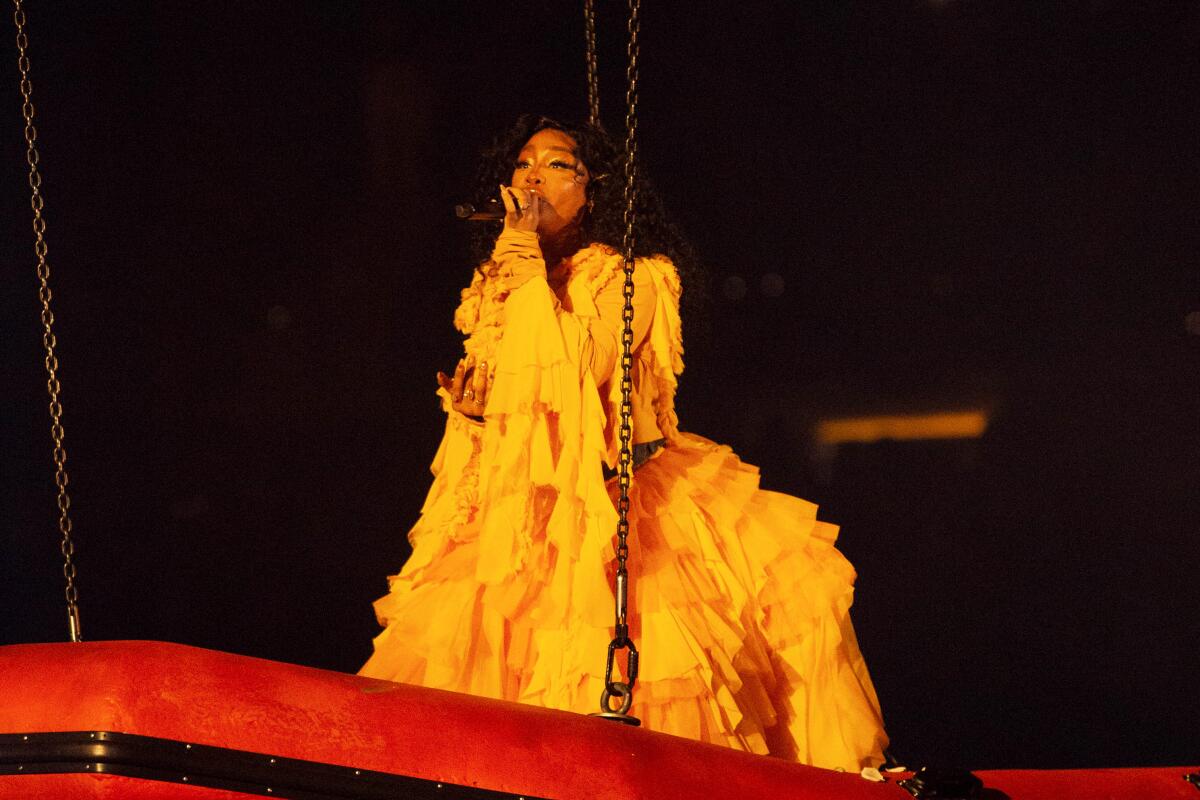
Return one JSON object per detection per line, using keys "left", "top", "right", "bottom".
{"left": 472, "top": 114, "right": 704, "bottom": 311}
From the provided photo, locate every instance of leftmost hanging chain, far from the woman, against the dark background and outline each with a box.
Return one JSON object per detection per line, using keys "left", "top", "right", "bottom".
{"left": 12, "top": 0, "right": 83, "bottom": 642}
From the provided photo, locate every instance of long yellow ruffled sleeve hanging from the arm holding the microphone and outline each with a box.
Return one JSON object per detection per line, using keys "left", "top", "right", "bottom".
{"left": 476, "top": 227, "right": 616, "bottom": 626}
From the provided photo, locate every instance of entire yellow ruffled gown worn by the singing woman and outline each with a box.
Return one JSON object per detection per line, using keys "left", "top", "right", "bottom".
{"left": 361, "top": 231, "right": 887, "bottom": 771}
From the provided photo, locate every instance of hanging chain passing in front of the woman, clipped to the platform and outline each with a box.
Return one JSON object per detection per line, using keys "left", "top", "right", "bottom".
{"left": 600, "top": 0, "right": 641, "bottom": 724}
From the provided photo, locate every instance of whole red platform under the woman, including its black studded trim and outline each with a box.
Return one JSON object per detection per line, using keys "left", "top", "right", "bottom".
{"left": 0, "top": 642, "right": 1200, "bottom": 800}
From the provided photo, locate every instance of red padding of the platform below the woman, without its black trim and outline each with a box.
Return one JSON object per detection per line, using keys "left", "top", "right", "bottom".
{"left": 0, "top": 642, "right": 908, "bottom": 800}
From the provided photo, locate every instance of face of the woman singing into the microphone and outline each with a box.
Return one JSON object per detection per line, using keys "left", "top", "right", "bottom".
{"left": 512, "top": 128, "right": 588, "bottom": 236}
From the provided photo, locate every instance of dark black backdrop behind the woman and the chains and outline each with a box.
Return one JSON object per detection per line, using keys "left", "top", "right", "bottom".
{"left": 0, "top": 0, "right": 1200, "bottom": 768}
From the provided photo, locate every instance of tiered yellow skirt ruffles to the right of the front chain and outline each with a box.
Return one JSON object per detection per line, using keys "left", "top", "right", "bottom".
{"left": 614, "top": 433, "right": 887, "bottom": 771}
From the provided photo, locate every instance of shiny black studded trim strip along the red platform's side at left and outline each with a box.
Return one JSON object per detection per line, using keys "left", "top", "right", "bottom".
{"left": 0, "top": 730, "right": 547, "bottom": 800}
